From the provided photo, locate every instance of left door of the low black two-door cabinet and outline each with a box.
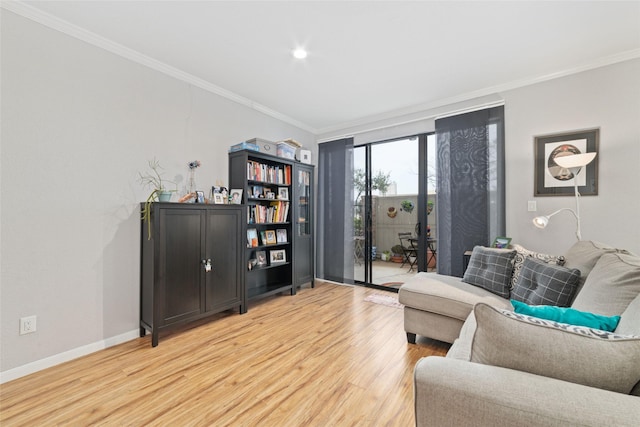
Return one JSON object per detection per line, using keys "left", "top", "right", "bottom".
{"left": 157, "top": 209, "right": 203, "bottom": 325}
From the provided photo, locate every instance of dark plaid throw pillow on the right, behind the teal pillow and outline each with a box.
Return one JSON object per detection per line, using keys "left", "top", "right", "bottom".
{"left": 511, "top": 258, "right": 580, "bottom": 307}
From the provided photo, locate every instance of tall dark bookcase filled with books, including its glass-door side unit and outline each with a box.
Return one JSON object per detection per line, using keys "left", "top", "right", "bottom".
{"left": 229, "top": 150, "right": 314, "bottom": 308}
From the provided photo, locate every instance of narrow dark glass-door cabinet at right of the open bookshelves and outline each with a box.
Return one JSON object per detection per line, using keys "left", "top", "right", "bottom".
{"left": 291, "top": 163, "right": 315, "bottom": 287}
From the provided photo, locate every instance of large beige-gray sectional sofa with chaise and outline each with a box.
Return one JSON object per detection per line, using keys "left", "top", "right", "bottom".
{"left": 398, "top": 241, "right": 640, "bottom": 426}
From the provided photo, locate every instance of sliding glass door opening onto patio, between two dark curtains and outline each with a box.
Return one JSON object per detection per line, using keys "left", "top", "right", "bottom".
{"left": 353, "top": 135, "right": 435, "bottom": 290}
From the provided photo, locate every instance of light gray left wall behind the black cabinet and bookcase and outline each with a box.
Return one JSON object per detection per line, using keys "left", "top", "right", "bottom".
{"left": 0, "top": 10, "right": 317, "bottom": 381}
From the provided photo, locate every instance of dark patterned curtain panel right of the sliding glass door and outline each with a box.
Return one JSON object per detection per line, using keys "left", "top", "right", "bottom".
{"left": 436, "top": 106, "right": 505, "bottom": 277}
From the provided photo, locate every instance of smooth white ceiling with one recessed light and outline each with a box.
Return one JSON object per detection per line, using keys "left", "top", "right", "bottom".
{"left": 8, "top": 1, "right": 640, "bottom": 134}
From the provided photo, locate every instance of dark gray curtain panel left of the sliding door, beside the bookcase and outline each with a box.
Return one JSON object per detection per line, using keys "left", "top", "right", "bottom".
{"left": 316, "top": 138, "right": 353, "bottom": 283}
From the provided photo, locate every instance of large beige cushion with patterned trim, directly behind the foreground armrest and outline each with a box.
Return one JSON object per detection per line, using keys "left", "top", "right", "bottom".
{"left": 471, "top": 303, "right": 640, "bottom": 394}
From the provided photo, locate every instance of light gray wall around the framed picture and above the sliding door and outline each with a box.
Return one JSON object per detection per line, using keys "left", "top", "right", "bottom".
{"left": 319, "top": 59, "right": 640, "bottom": 254}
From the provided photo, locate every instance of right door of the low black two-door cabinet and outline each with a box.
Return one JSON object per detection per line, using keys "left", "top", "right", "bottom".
{"left": 204, "top": 208, "right": 245, "bottom": 311}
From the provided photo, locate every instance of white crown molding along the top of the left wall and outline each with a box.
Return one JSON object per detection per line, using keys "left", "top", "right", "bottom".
{"left": 0, "top": 0, "right": 317, "bottom": 135}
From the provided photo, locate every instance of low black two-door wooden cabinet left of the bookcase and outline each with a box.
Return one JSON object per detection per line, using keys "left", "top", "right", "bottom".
{"left": 140, "top": 203, "right": 246, "bottom": 347}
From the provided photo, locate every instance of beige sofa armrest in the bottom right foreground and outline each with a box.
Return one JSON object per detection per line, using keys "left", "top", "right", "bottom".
{"left": 414, "top": 356, "right": 640, "bottom": 426}
